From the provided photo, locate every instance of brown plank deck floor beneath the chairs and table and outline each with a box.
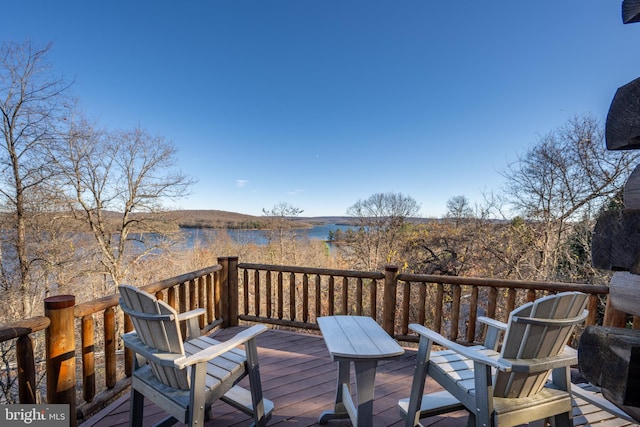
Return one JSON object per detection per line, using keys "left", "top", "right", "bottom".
{"left": 81, "top": 328, "right": 633, "bottom": 427}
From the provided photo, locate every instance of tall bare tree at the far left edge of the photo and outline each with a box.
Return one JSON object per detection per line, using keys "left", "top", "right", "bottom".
{"left": 0, "top": 42, "right": 69, "bottom": 316}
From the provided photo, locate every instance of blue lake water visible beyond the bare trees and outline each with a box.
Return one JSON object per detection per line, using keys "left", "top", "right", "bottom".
{"left": 181, "top": 224, "right": 353, "bottom": 246}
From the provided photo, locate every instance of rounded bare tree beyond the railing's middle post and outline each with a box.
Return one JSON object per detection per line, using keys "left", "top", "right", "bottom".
{"left": 343, "top": 193, "right": 420, "bottom": 270}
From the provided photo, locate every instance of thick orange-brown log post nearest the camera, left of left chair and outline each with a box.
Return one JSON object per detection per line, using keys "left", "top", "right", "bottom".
{"left": 44, "top": 295, "right": 77, "bottom": 427}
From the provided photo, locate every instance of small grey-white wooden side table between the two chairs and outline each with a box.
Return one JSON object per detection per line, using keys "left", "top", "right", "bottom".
{"left": 318, "top": 316, "right": 404, "bottom": 426}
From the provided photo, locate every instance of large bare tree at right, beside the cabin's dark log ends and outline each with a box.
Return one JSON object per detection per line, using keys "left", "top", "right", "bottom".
{"left": 503, "top": 116, "right": 638, "bottom": 280}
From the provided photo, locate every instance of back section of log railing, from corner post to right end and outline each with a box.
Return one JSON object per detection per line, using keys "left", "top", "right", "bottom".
{"left": 238, "top": 263, "right": 609, "bottom": 344}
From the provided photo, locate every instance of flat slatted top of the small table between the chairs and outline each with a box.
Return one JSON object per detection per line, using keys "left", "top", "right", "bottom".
{"left": 318, "top": 316, "right": 404, "bottom": 360}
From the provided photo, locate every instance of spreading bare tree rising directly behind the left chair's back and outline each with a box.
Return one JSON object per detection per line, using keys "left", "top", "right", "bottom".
{"left": 52, "top": 119, "right": 192, "bottom": 292}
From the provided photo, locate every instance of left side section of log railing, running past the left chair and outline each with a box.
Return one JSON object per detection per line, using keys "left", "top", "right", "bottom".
{"left": 0, "top": 259, "right": 228, "bottom": 426}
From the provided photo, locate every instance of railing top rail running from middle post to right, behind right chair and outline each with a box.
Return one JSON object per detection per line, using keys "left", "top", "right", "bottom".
{"left": 398, "top": 273, "right": 609, "bottom": 295}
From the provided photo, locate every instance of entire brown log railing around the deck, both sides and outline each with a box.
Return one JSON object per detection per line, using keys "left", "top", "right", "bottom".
{"left": 0, "top": 257, "right": 626, "bottom": 425}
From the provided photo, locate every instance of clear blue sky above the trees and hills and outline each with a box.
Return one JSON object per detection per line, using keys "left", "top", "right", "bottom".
{"left": 5, "top": 0, "right": 640, "bottom": 217}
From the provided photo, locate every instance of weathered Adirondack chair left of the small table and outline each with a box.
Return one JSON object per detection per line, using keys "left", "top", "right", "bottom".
{"left": 118, "top": 285, "right": 273, "bottom": 426}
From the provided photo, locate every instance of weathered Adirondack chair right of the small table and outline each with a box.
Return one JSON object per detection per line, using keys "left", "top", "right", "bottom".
{"left": 398, "top": 292, "right": 587, "bottom": 427}
